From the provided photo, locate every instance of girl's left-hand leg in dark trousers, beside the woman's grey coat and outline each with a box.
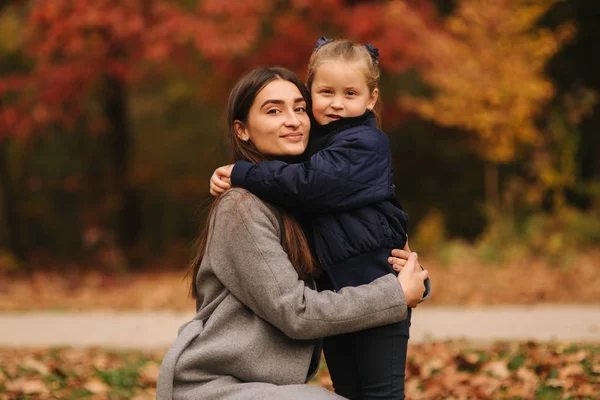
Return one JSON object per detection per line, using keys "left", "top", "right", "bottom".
{"left": 323, "top": 333, "right": 358, "bottom": 399}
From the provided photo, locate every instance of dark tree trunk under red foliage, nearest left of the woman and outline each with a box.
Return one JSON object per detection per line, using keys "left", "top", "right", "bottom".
{"left": 104, "top": 77, "right": 141, "bottom": 250}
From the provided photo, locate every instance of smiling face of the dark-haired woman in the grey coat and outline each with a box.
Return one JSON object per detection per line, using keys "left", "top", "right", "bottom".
{"left": 234, "top": 79, "right": 310, "bottom": 156}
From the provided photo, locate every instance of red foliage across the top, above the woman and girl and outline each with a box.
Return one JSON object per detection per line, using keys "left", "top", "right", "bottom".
{"left": 0, "top": 0, "right": 435, "bottom": 138}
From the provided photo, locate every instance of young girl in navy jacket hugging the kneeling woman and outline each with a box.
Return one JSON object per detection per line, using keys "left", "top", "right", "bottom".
{"left": 211, "top": 38, "right": 429, "bottom": 399}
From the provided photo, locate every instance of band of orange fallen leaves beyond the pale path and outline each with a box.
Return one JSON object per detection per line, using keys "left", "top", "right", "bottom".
{"left": 0, "top": 251, "right": 600, "bottom": 311}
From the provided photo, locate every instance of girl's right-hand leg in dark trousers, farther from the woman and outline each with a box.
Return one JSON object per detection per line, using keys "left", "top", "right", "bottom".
{"left": 354, "top": 309, "right": 411, "bottom": 400}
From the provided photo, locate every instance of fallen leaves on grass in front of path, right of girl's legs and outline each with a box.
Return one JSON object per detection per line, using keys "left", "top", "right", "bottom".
{"left": 398, "top": 342, "right": 600, "bottom": 400}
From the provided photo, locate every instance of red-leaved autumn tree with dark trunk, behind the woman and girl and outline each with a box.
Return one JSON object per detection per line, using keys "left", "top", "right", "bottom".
{"left": 0, "top": 0, "right": 450, "bottom": 262}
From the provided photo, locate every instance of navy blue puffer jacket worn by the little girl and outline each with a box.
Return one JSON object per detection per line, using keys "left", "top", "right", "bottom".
{"left": 231, "top": 112, "right": 408, "bottom": 289}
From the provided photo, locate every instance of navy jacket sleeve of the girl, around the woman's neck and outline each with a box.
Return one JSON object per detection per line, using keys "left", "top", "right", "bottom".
{"left": 231, "top": 130, "right": 394, "bottom": 212}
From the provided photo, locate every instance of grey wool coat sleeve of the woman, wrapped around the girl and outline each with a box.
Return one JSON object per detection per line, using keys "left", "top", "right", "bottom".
{"left": 205, "top": 189, "right": 407, "bottom": 339}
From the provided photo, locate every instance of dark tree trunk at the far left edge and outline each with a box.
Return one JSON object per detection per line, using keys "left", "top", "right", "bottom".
{"left": 0, "top": 139, "right": 25, "bottom": 259}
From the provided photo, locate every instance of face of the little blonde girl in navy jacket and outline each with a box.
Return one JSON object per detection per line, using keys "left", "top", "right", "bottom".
{"left": 310, "top": 60, "right": 379, "bottom": 125}
